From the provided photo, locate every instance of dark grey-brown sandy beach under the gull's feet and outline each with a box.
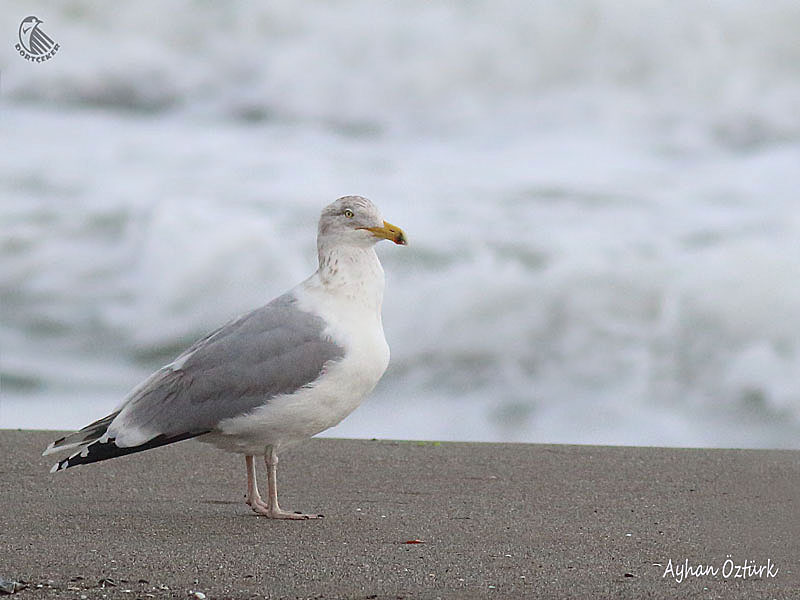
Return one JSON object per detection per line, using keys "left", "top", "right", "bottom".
{"left": 0, "top": 431, "right": 800, "bottom": 600}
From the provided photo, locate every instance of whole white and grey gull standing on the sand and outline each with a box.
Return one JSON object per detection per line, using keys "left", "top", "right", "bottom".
{"left": 44, "top": 196, "right": 407, "bottom": 519}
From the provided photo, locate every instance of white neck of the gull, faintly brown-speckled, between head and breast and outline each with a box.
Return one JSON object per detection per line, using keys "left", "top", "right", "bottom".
{"left": 315, "top": 244, "right": 384, "bottom": 313}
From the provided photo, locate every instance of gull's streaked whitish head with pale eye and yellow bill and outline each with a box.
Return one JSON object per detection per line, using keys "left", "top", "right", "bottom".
{"left": 317, "top": 196, "right": 408, "bottom": 247}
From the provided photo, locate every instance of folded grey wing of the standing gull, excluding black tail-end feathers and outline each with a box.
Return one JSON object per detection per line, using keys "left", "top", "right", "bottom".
{"left": 112, "top": 293, "right": 344, "bottom": 435}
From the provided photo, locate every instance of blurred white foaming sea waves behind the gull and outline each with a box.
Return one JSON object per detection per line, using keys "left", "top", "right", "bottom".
{"left": 0, "top": 0, "right": 800, "bottom": 448}
